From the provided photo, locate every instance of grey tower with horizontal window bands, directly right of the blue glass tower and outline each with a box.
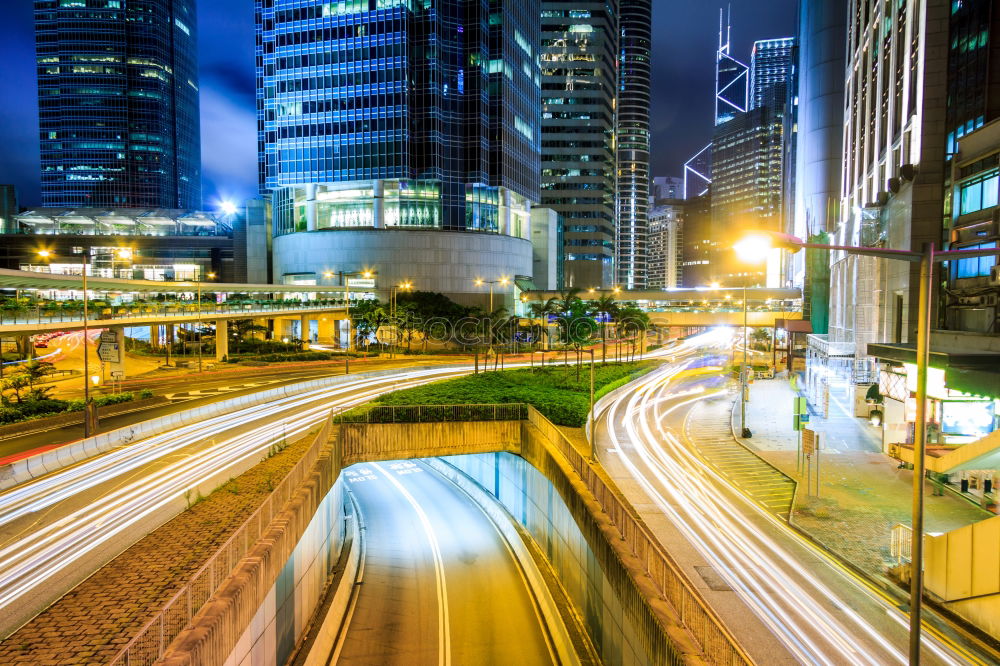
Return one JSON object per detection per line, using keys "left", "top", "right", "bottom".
{"left": 541, "top": 0, "right": 619, "bottom": 288}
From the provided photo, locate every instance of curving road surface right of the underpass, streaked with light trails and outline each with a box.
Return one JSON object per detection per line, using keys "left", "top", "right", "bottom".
{"left": 596, "top": 340, "right": 985, "bottom": 666}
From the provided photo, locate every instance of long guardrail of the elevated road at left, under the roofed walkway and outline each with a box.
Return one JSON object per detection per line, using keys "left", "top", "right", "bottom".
{"left": 0, "top": 301, "right": 344, "bottom": 326}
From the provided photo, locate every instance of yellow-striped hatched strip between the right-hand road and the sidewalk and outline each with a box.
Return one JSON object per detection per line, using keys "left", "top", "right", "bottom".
{"left": 684, "top": 400, "right": 795, "bottom": 520}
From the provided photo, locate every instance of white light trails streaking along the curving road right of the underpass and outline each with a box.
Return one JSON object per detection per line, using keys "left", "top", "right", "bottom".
{"left": 604, "top": 358, "right": 976, "bottom": 665}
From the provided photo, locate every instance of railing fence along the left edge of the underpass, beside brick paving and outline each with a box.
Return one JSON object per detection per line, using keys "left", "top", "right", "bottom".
{"left": 110, "top": 415, "right": 332, "bottom": 666}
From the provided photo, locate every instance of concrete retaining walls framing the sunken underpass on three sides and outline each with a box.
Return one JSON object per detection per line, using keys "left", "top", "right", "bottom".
{"left": 154, "top": 404, "right": 746, "bottom": 666}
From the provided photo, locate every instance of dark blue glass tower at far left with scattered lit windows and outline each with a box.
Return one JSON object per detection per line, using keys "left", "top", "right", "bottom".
{"left": 35, "top": 0, "right": 202, "bottom": 209}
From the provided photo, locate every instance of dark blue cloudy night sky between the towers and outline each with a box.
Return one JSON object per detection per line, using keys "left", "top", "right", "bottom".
{"left": 0, "top": 0, "right": 795, "bottom": 207}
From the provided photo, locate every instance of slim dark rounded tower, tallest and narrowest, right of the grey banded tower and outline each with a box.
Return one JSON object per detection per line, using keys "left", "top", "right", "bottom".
{"left": 615, "top": 0, "right": 652, "bottom": 289}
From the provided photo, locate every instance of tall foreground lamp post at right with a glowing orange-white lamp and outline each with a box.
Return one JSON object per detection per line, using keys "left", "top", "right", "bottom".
{"left": 736, "top": 232, "right": 1000, "bottom": 664}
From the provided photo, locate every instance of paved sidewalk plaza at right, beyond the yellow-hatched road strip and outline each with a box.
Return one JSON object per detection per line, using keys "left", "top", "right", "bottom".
{"left": 733, "top": 379, "right": 993, "bottom": 576}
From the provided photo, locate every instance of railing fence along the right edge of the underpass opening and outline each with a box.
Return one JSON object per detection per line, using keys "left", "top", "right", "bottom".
{"left": 527, "top": 408, "right": 753, "bottom": 665}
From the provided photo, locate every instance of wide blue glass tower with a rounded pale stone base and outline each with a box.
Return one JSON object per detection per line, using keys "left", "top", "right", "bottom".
{"left": 256, "top": 0, "right": 541, "bottom": 304}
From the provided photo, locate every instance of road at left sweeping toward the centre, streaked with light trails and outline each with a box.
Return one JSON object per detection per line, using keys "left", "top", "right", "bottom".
{"left": 0, "top": 368, "right": 468, "bottom": 636}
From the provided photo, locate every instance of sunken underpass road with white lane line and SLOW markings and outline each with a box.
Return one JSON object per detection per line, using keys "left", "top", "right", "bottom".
{"left": 330, "top": 462, "right": 557, "bottom": 666}
